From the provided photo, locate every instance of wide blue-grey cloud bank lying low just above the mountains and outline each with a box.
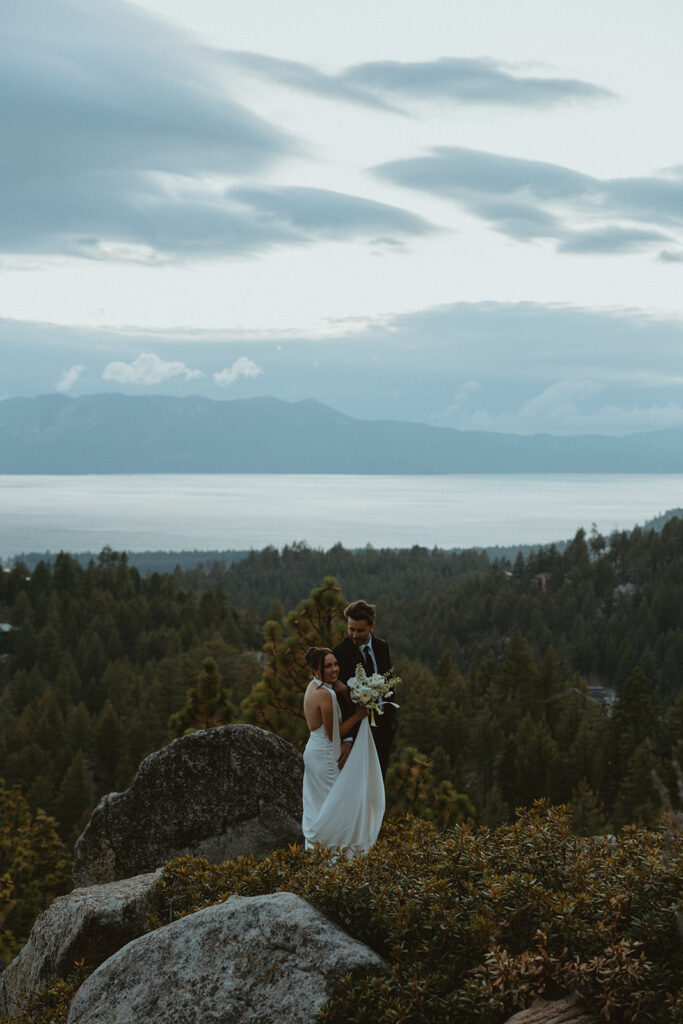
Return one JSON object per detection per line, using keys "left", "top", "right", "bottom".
{"left": 6, "top": 299, "right": 683, "bottom": 435}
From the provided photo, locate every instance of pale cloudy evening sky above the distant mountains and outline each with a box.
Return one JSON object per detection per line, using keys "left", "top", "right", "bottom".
{"left": 0, "top": 0, "right": 683, "bottom": 435}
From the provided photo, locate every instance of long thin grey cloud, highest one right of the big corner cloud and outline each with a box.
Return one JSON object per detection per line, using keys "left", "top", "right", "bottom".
{"left": 223, "top": 50, "right": 612, "bottom": 112}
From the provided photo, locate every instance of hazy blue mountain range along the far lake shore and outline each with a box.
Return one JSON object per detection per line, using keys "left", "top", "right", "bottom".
{"left": 0, "top": 394, "right": 683, "bottom": 474}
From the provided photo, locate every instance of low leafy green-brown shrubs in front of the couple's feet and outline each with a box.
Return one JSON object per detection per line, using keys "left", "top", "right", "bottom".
{"left": 159, "top": 802, "right": 683, "bottom": 1024}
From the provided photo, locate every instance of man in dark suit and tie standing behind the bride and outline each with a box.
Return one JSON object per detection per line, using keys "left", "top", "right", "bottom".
{"left": 334, "top": 600, "right": 398, "bottom": 778}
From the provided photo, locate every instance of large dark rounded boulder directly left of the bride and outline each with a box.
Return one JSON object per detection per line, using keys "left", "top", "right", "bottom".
{"left": 74, "top": 725, "right": 303, "bottom": 886}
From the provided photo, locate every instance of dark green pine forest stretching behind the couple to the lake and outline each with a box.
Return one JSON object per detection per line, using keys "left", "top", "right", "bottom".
{"left": 0, "top": 518, "right": 683, "bottom": 959}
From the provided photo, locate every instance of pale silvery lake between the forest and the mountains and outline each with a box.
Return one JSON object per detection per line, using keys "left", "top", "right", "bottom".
{"left": 0, "top": 473, "right": 683, "bottom": 558}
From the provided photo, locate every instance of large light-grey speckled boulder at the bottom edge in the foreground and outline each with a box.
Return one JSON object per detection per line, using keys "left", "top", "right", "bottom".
{"left": 68, "top": 892, "right": 388, "bottom": 1024}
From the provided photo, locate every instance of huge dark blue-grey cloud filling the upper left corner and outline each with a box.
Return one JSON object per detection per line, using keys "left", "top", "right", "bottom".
{"left": 0, "top": 0, "right": 290, "bottom": 258}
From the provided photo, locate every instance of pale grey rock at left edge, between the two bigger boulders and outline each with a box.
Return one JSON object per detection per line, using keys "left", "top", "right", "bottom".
{"left": 0, "top": 871, "right": 162, "bottom": 1015}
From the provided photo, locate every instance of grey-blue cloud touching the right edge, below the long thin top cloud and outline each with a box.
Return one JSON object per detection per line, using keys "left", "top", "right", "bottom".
{"left": 374, "top": 146, "right": 683, "bottom": 254}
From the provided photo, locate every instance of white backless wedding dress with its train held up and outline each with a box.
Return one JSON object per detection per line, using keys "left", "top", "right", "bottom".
{"left": 301, "top": 680, "right": 384, "bottom": 856}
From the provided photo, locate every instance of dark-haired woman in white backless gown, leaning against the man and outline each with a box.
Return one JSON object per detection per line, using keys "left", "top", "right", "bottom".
{"left": 301, "top": 647, "right": 384, "bottom": 856}
